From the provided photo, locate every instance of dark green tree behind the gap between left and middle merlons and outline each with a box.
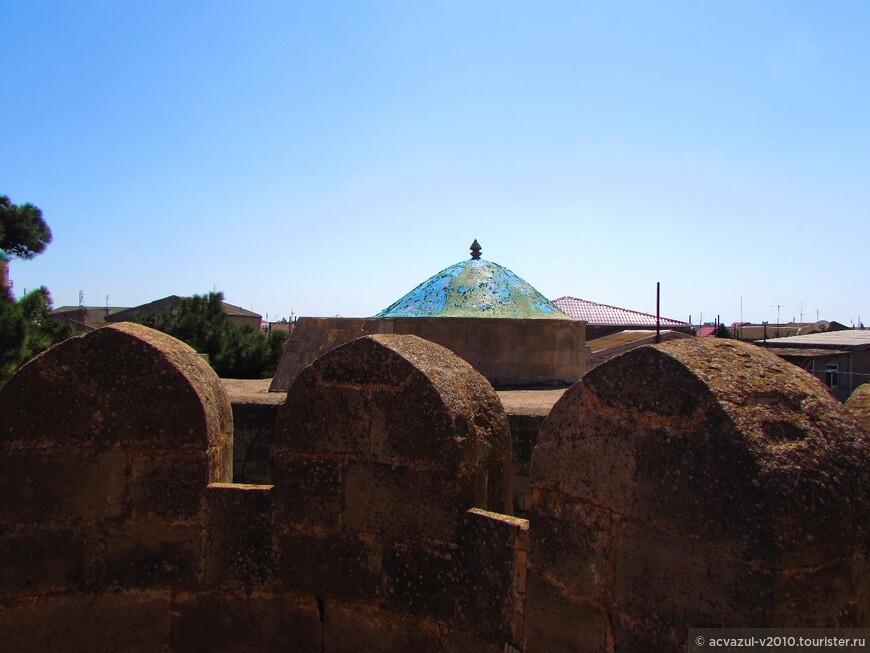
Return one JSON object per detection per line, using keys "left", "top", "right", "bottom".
{"left": 135, "top": 292, "right": 287, "bottom": 379}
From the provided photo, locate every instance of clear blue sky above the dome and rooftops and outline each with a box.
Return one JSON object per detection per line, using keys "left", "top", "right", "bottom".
{"left": 0, "top": 0, "right": 870, "bottom": 324}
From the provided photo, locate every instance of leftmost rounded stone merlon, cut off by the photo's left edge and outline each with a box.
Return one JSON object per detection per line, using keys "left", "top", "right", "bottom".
{"left": 0, "top": 324, "right": 268, "bottom": 651}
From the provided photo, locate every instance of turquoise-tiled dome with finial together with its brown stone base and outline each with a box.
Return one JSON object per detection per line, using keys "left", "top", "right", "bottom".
{"left": 270, "top": 240, "right": 587, "bottom": 392}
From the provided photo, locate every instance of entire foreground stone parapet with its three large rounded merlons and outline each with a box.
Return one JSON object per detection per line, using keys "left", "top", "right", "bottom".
{"left": 0, "top": 324, "right": 870, "bottom": 653}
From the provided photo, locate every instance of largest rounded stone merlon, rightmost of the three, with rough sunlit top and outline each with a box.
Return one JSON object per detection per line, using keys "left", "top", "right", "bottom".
{"left": 527, "top": 339, "right": 870, "bottom": 652}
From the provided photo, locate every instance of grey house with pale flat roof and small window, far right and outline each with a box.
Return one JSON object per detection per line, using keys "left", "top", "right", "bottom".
{"left": 755, "top": 329, "right": 870, "bottom": 401}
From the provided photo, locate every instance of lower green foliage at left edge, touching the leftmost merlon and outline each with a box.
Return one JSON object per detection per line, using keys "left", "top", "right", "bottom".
{"left": 0, "top": 286, "right": 74, "bottom": 386}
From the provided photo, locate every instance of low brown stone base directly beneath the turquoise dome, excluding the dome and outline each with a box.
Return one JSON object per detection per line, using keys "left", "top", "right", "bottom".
{"left": 271, "top": 317, "right": 587, "bottom": 391}
